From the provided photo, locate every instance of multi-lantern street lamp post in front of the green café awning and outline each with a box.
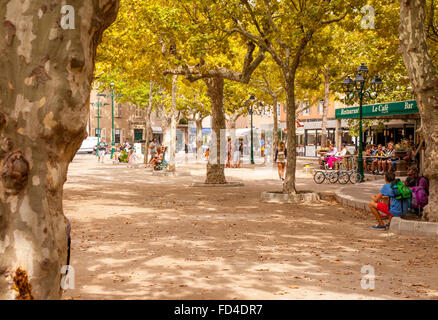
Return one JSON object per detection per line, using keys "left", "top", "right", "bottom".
{"left": 342, "top": 63, "right": 383, "bottom": 182}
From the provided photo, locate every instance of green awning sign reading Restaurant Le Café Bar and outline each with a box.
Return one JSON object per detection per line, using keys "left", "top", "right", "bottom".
{"left": 336, "top": 100, "right": 418, "bottom": 119}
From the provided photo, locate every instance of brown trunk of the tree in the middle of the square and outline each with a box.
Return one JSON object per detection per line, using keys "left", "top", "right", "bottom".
{"left": 204, "top": 77, "right": 226, "bottom": 184}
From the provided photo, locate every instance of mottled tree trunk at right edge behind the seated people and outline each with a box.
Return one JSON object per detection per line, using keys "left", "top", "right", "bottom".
{"left": 399, "top": 0, "right": 438, "bottom": 221}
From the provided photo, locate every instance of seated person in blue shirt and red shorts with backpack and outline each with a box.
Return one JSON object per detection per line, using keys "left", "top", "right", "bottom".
{"left": 368, "top": 172, "right": 404, "bottom": 230}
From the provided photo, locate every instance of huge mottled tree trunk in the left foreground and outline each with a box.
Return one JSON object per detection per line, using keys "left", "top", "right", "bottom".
{"left": 0, "top": 0, "right": 118, "bottom": 299}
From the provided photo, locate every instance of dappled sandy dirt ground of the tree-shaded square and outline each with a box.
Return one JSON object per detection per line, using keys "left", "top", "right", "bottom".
{"left": 63, "top": 157, "right": 438, "bottom": 299}
